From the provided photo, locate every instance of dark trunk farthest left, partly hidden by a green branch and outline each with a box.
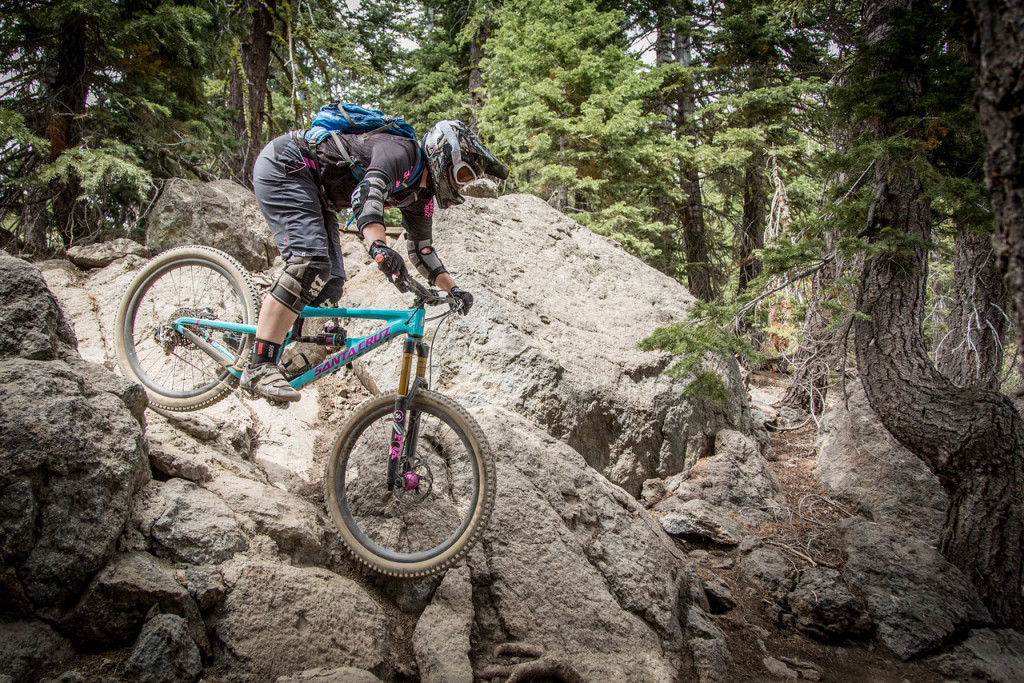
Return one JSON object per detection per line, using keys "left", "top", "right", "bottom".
{"left": 46, "top": 15, "right": 89, "bottom": 248}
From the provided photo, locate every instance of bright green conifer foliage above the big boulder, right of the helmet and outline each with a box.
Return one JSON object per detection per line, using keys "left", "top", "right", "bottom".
{"left": 480, "top": 0, "right": 672, "bottom": 210}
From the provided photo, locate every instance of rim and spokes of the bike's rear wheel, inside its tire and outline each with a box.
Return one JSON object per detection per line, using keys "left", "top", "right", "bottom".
{"left": 124, "top": 259, "right": 249, "bottom": 398}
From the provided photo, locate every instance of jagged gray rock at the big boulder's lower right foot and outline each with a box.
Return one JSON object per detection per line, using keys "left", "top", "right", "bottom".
{"left": 643, "top": 430, "right": 785, "bottom": 545}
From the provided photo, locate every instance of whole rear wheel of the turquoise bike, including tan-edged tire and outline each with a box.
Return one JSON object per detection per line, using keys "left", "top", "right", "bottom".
{"left": 115, "top": 247, "right": 259, "bottom": 411}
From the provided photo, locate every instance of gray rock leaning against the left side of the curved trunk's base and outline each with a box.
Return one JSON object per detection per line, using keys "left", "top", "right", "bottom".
{"left": 814, "top": 382, "right": 949, "bottom": 544}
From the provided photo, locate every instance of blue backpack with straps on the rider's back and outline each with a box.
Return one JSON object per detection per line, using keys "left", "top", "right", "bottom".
{"left": 305, "top": 102, "right": 424, "bottom": 191}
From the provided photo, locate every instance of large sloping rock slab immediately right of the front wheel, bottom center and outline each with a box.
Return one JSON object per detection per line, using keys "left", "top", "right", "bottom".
{"left": 470, "top": 408, "right": 685, "bottom": 681}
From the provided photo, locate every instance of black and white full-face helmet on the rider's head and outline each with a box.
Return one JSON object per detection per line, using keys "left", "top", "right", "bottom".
{"left": 423, "top": 121, "right": 509, "bottom": 209}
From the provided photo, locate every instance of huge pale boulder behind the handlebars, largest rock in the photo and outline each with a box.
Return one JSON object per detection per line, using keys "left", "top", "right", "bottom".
{"left": 345, "top": 196, "right": 753, "bottom": 496}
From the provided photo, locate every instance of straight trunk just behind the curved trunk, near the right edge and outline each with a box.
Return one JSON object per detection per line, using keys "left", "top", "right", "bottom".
{"left": 935, "top": 232, "right": 1007, "bottom": 391}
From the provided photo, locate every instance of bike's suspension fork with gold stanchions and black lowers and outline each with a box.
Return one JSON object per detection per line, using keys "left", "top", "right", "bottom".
{"left": 387, "top": 337, "right": 430, "bottom": 490}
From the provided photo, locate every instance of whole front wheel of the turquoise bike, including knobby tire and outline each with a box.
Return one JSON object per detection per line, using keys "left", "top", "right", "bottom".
{"left": 325, "top": 389, "right": 496, "bottom": 577}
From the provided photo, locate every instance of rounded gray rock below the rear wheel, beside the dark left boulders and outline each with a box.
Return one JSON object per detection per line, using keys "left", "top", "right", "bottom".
{"left": 132, "top": 479, "right": 249, "bottom": 564}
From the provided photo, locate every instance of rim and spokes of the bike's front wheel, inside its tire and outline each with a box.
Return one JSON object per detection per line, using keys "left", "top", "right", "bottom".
{"left": 334, "top": 404, "right": 480, "bottom": 563}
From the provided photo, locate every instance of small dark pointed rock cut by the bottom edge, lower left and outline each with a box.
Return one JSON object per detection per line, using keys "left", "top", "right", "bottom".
{"left": 125, "top": 614, "right": 203, "bottom": 683}
